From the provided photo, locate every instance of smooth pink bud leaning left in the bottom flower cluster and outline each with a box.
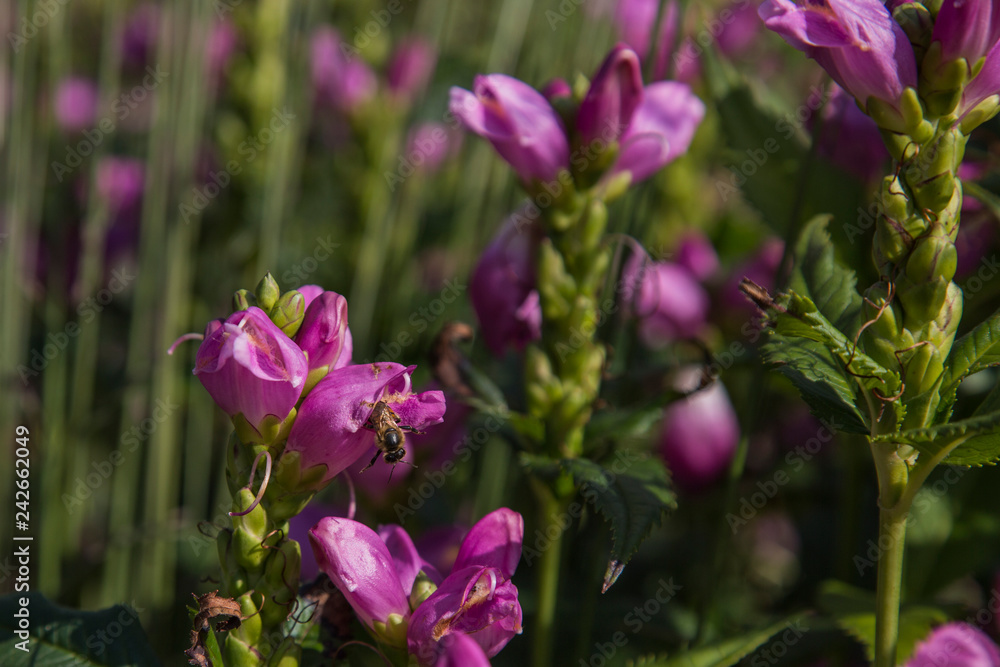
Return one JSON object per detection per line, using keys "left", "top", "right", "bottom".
{"left": 309, "top": 517, "right": 410, "bottom": 644}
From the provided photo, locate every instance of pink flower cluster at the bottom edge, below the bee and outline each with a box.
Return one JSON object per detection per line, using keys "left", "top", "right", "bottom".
{"left": 309, "top": 508, "right": 524, "bottom": 666}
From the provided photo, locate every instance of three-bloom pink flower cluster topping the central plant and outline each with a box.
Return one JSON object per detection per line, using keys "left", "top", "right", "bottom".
{"left": 451, "top": 44, "right": 705, "bottom": 193}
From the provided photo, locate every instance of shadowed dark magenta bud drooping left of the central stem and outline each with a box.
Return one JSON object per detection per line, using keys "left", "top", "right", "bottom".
{"left": 469, "top": 211, "right": 542, "bottom": 356}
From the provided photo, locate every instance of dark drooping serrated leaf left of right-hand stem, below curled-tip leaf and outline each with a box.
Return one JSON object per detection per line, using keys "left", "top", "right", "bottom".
{"left": 761, "top": 334, "right": 871, "bottom": 435}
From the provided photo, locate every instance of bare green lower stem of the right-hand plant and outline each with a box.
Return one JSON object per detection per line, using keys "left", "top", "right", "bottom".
{"left": 875, "top": 509, "right": 907, "bottom": 667}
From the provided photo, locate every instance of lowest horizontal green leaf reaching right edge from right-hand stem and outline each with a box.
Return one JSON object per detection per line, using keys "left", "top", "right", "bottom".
{"left": 878, "top": 412, "right": 1000, "bottom": 466}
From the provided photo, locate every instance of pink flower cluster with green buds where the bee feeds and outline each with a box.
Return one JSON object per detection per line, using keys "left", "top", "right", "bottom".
{"left": 183, "top": 278, "right": 445, "bottom": 484}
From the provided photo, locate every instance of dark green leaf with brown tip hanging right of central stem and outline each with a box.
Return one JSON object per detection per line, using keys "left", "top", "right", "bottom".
{"left": 563, "top": 450, "right": 677, "bottom": 591}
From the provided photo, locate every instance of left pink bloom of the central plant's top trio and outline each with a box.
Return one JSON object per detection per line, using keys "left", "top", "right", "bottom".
{"left": 449, "top": 74, "right": 569, "bottom": 185}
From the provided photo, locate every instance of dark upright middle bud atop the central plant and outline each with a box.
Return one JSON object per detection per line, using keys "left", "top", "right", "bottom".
{"left": 576, "top": 44, "right": 643, "bottom": 146}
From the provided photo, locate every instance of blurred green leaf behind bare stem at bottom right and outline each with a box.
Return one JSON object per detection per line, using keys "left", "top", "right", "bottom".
{"left": 818, "top": 581, "right": 950, "bottom": 663}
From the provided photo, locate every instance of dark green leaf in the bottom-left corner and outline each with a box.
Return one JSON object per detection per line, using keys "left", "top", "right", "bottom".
{"left": 0, "top": 593, "right": 160, "bottom": 667}
